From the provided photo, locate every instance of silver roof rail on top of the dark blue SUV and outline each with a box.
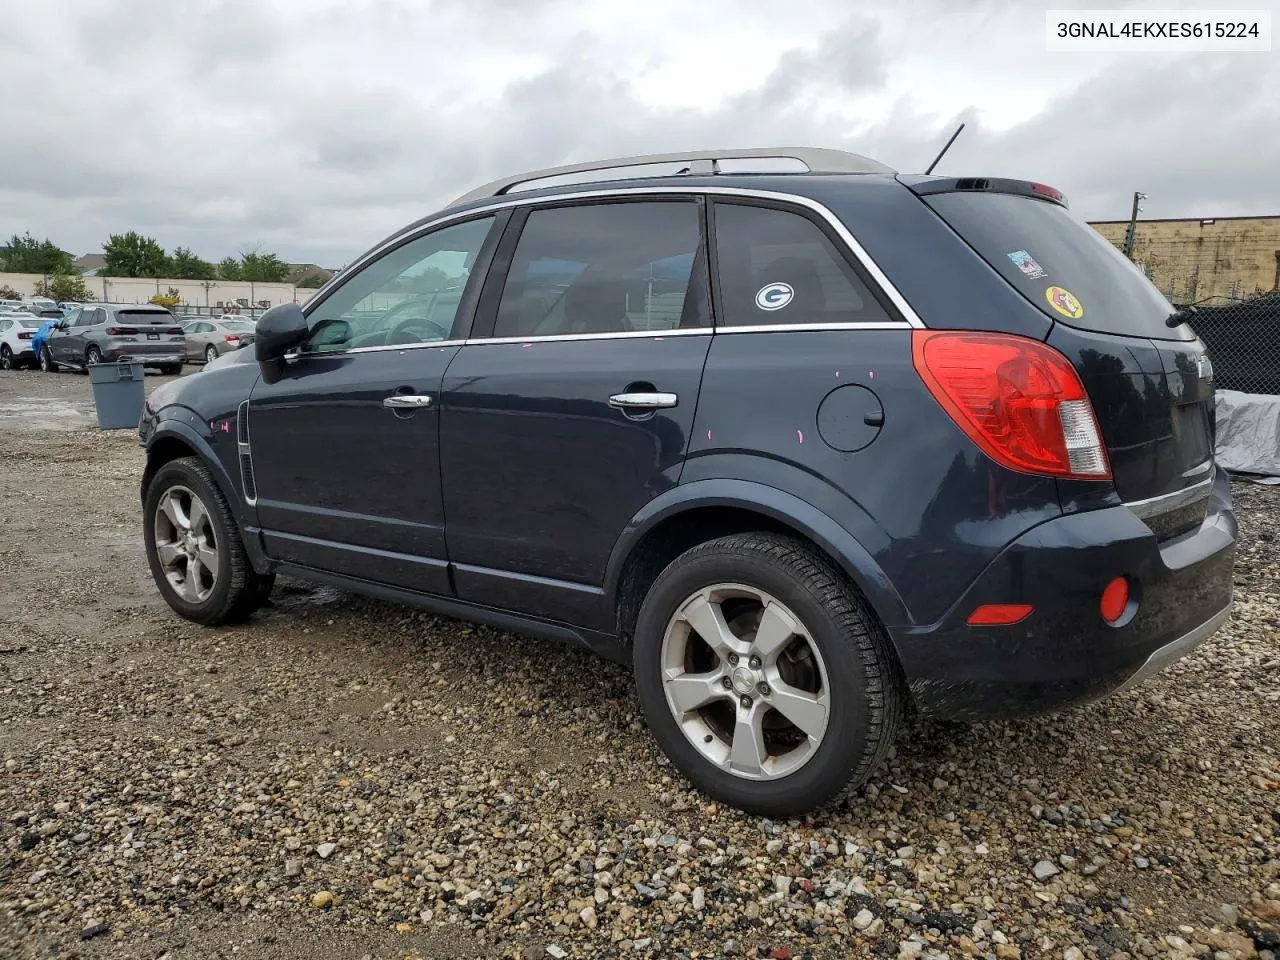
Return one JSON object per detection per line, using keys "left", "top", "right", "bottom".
{"left": 449, "top": 147, "right": 895, "bottom": 206}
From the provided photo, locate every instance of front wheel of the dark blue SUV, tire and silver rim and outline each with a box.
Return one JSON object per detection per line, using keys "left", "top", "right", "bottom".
{"left": 142, "top": 457, "right": 274, "bottom": 626}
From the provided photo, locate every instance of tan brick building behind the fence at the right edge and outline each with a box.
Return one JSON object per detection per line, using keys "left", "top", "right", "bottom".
{"left": 1092, "top": 215, "right": 1280, "bottom": 303}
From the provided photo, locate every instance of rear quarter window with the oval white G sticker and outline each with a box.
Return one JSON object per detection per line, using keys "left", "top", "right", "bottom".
{"left": 714, "top": 202, "right": 891, "bottom": 326}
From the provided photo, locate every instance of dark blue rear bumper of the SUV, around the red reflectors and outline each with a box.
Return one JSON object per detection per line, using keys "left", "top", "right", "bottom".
{"left": 891, "top": 471, "right": 1236, "bottom": 719}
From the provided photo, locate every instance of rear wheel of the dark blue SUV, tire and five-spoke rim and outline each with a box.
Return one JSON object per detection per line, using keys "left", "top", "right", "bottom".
{"left": 634, "top": 534, "right": 905, "bottom": 817}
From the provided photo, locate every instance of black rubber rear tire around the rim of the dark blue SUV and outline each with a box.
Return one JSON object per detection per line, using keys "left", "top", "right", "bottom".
{"left": 634, "top": 537, "right": 874, "bottom": 815}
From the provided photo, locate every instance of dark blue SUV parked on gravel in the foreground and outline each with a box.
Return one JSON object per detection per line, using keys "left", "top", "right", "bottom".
{"left": 141, "top": 148, "right": 1235, "bottom": 815}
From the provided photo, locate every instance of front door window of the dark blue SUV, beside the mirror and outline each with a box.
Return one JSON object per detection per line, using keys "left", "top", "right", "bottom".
{"left": 302, "top": 216, "right": 494, "bottom": 353}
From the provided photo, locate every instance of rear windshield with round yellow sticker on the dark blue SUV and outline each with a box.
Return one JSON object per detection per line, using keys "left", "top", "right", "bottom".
{"left": 924, "top": 192, "right": 1193, "bottom": 340}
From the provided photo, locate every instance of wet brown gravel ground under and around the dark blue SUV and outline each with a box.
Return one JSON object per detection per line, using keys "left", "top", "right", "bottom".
{"left": 0, "top": 372, "right": 1280, "bottom": 960}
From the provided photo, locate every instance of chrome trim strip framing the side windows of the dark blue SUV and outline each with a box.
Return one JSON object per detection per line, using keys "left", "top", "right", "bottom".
{"left": 298, "top": 186, "right": 924, "bottom": 357}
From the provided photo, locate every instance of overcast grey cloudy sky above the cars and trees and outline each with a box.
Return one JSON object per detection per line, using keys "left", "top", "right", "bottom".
{"left": 0, "top": 0, "right": 1280, "bottom": 266}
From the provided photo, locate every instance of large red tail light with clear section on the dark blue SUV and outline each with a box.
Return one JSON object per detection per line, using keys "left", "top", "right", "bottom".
{"left": 911, "top": 330, "right": 1111, "bottom": 480}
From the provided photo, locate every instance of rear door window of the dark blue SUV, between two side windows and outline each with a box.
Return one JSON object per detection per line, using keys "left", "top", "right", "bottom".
{"left": 493, "top": 201, "right": 708, "bottom": 337}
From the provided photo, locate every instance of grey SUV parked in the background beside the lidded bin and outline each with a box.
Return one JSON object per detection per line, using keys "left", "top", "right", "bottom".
{"left": 40, "top": 303, "right": 187, "bottom": 374}
